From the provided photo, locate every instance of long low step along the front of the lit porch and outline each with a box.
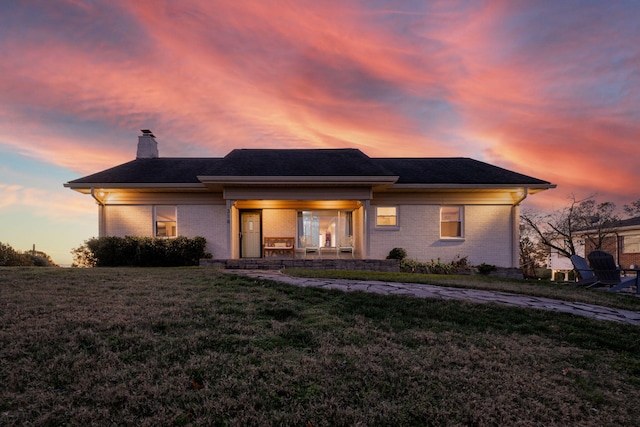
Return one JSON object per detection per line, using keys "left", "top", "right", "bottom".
{"left": 200, "top": 258, "right": 400, "bottom": 272}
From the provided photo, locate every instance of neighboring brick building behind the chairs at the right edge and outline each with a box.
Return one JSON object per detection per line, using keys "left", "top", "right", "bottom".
{"left": 585, "top": 217, "right": 640, "bottom": 268}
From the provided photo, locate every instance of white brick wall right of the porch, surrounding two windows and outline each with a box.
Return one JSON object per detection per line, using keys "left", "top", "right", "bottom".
{"left": 370, "top": 205, "right": 512, "bottom": 267}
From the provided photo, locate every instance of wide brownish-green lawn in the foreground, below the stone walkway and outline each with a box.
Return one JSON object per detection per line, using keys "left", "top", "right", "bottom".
{"left": 0, "top": 267, "right": 640, "bottom": 426}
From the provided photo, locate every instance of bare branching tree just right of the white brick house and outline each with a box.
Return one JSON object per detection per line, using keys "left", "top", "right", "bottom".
{"left": 521, "top": 194, "right": 619, "bottom": 258}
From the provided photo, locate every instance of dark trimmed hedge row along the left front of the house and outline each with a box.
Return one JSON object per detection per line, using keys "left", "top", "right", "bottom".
{"left": 73, "top": 236, "right": 211, "bottom": 267}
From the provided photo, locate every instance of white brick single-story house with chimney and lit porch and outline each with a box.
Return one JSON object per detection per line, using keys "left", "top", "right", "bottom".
{"left": 64, "top": 130, "right": 555, "bottom": 267}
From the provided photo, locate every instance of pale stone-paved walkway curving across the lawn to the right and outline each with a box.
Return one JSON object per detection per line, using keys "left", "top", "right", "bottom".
{"left": 227, "top": 270, "right": 640, "bottom": 325}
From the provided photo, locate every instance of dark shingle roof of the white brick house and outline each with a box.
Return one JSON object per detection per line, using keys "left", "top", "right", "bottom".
{"left": 69, "top": 149, "right": 550, "bottom": 186}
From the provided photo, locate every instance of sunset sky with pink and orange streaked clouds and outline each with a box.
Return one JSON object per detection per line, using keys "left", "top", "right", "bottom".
{"left": 0, "top": 0, "right": 640, "bottom": 265}
